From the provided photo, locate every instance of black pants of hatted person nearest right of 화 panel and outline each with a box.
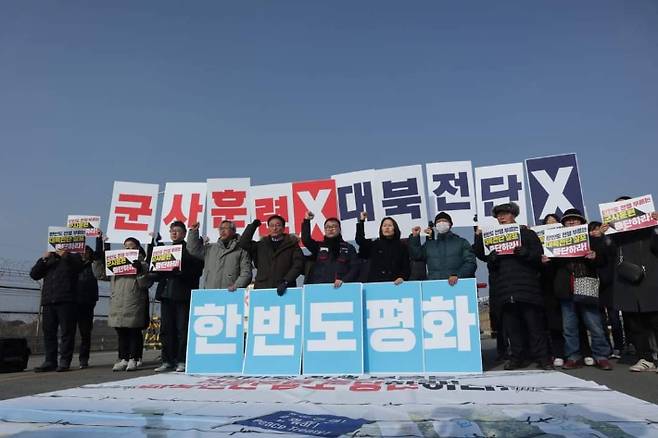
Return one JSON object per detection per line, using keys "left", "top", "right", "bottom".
{"left": 502, "top": 303, "right": 549, "bottom": 362}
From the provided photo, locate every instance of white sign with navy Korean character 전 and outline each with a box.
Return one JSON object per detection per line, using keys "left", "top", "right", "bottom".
{"left": 425, "top": 161, "right": 476, "bottom": 227}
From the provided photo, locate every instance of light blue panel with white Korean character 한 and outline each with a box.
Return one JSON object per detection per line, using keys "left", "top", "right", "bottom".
{"left": 186, "top": 289, "right": 244, "bottom": 374}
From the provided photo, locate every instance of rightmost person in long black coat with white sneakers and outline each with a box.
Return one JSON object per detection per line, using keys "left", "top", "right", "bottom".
{"left": 601, "top": 196, "right": 658, "bottom": 372}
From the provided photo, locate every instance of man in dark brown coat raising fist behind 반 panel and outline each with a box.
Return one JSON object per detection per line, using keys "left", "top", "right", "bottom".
{"left": 238, "top": 215, "right": 304, "bottom": 296}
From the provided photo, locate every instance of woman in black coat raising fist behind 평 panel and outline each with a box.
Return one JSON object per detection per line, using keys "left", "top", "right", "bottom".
{"left": 355, "top": 211, "right": 410, "bottom": 285}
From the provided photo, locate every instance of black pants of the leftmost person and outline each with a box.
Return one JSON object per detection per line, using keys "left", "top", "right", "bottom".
{"left": 43, "top": 303, "right": 76, "bottom": 367}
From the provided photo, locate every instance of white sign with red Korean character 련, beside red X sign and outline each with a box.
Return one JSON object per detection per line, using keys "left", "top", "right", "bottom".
{"left": 249, "top": 183, "right": 296, "bottom": 239}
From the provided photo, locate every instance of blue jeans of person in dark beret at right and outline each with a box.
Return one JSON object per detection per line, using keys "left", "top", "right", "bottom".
{"left": 560, "top": 300, "right": 610, "bottom": 360}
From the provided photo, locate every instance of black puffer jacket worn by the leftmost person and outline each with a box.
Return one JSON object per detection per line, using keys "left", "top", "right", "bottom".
{"left": 30, "top": 253, "right": 82, "bottom": 306}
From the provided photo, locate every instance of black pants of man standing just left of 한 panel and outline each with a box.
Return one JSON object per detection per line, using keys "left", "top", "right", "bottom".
{"left": 160, "top": 299, "right": 190, "bottom": 364}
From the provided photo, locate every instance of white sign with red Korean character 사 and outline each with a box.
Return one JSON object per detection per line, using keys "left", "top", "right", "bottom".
{"left": 160, "top": 183, "right": 206, "bottom": 242}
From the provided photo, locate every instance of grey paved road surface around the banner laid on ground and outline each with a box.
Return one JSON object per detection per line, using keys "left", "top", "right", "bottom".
{"left": 0, "top": 339, "right": 658, "bottom": 404}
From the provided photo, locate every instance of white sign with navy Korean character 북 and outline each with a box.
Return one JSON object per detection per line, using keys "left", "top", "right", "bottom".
{"left": 373, "top": 165, "right": 428, "bottom": 236}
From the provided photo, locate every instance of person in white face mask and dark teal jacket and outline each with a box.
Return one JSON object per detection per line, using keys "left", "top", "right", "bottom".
{"left": 409, "top": 212, "right": 477, "bottom": 286}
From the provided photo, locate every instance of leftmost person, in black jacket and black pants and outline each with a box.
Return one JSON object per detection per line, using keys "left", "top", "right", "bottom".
{"left": 30, "top": 250, "right": 82, "bottom": 373}
